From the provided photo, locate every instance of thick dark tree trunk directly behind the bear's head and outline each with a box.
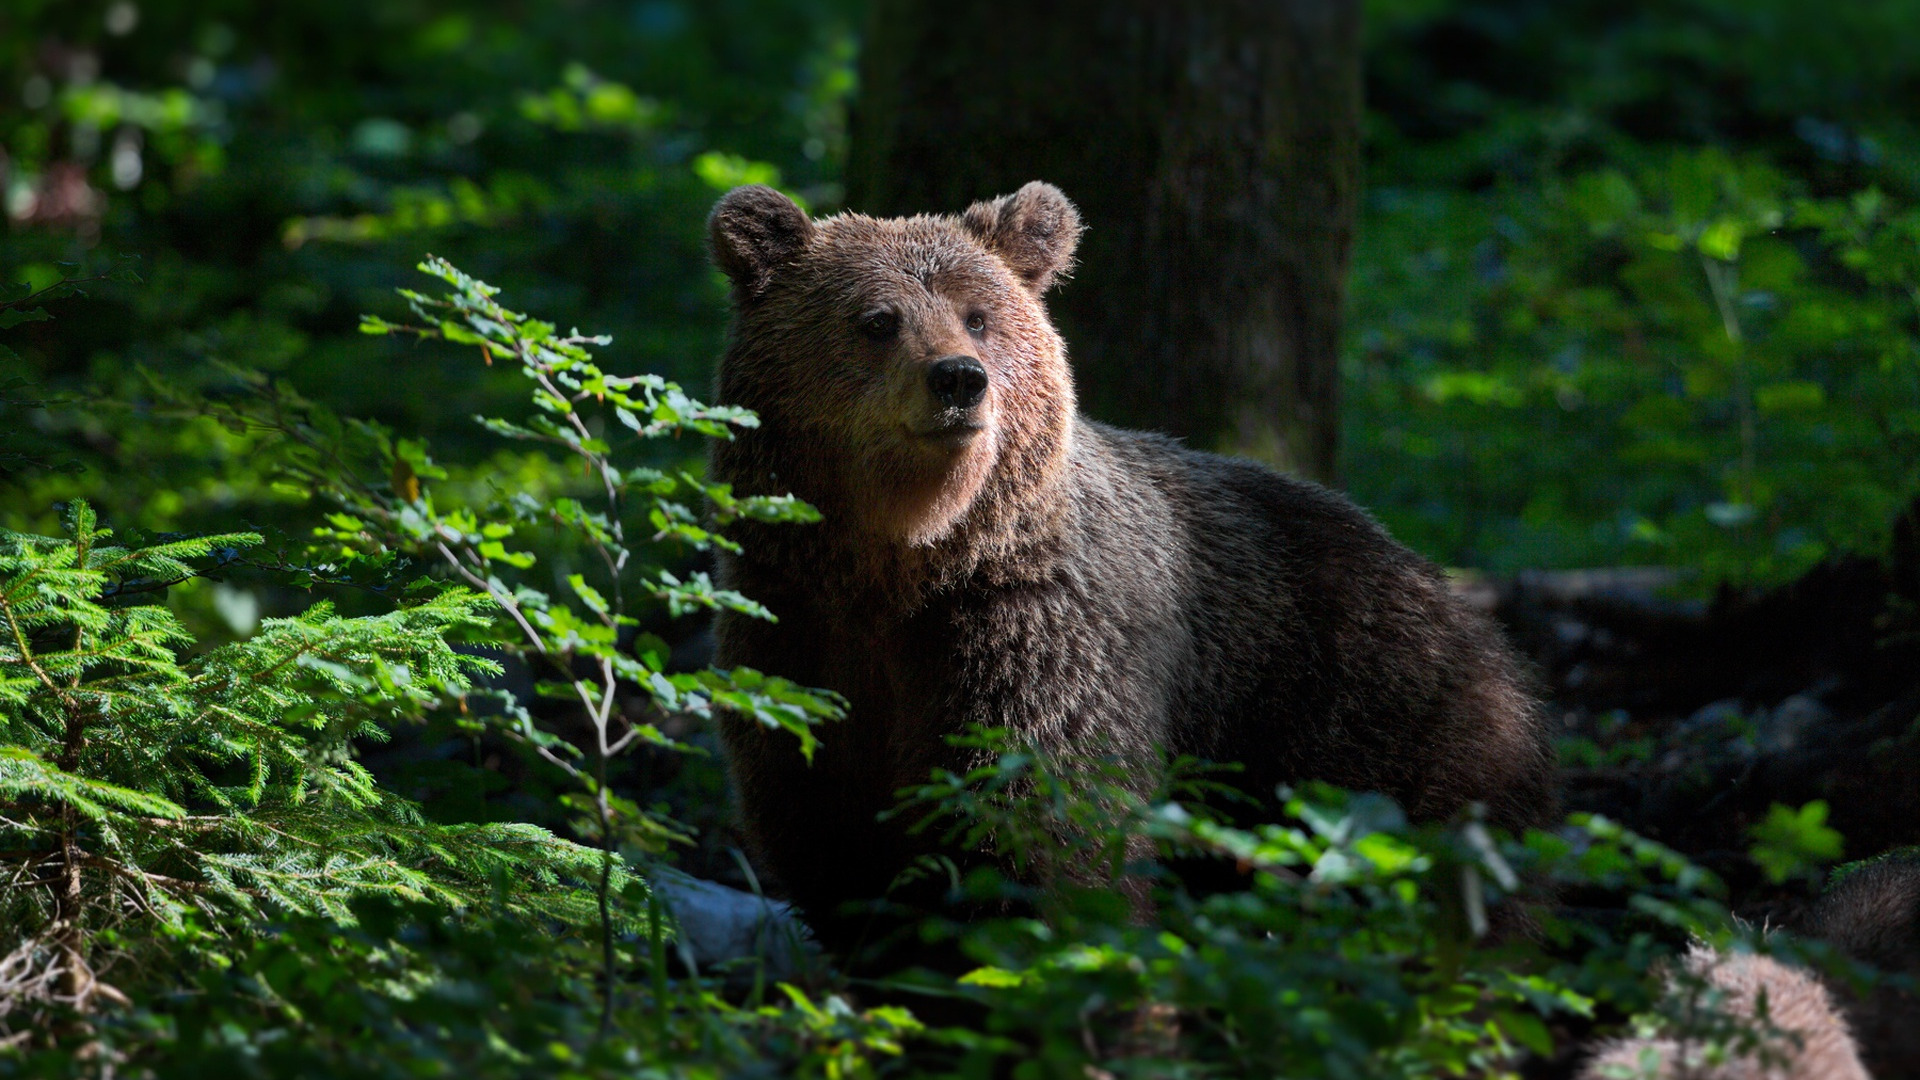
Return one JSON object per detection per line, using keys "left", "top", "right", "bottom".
{"left": 847, "top": 0, "right": 1359, "bottom": 482}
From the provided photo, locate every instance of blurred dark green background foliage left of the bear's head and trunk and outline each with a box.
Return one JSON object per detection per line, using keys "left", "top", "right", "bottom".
{"left": 0, "top": 0, "right": 860, "bottom": 541}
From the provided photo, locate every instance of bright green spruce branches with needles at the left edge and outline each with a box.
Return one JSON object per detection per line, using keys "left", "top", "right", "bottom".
{"left": 0, "top": 502, "right": 610, "bottom": 1030}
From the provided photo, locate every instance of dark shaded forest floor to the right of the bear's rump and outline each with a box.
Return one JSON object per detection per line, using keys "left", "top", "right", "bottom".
{"left": 1463, "top": 505, "right": 1920, "bottom": 914}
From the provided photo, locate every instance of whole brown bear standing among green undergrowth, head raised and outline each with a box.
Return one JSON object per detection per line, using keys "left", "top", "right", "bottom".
{"left": 708, "top": 183, "right": 1553, "bottom": 937}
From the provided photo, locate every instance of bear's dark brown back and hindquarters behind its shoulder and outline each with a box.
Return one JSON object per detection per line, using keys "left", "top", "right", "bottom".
{"left": 1077, "top": 421, "right": 1553, "bottom": 824}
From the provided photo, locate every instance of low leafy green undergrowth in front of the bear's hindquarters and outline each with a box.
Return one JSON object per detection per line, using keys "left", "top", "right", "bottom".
{"left": 871, "top": 732, "right": 1784, "bottom": 1076}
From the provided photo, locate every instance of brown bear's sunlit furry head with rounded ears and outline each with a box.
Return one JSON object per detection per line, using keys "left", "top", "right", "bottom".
{"left": 708, "top": 183, "right": 1081, "bottom": 548}
